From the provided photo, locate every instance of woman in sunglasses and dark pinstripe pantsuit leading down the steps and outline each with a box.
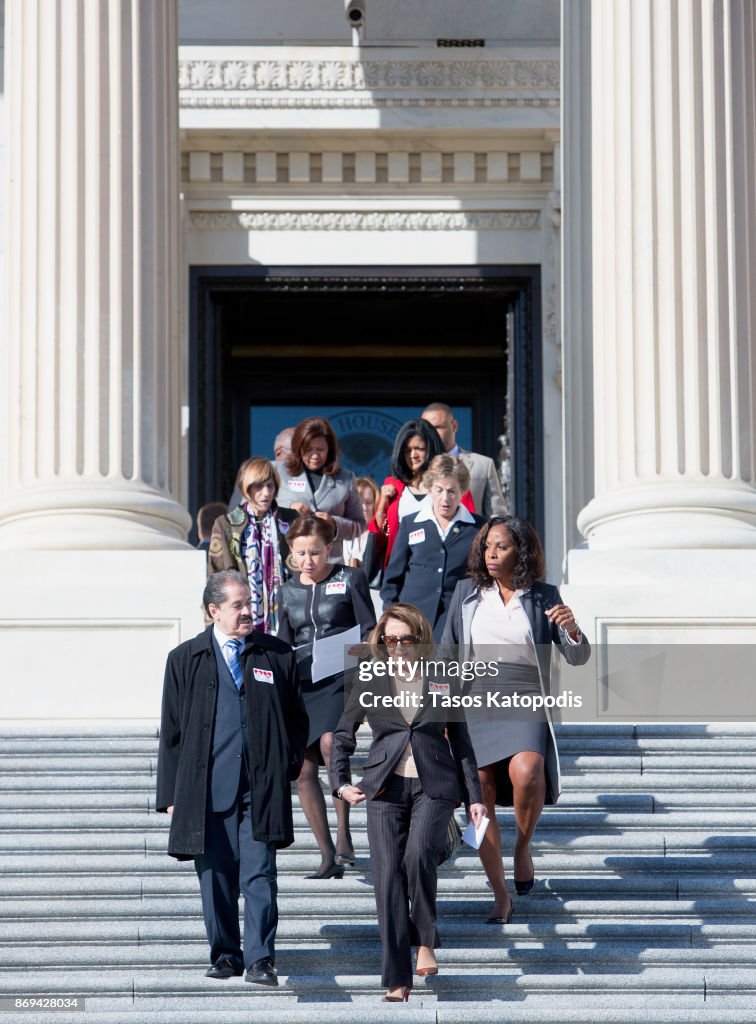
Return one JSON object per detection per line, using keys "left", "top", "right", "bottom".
{"left": 330, "top": 604, "right": 486, "bottom": 1002}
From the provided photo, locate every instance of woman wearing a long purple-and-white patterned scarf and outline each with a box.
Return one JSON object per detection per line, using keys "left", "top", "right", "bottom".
{"left": 207, "top": 456, "right": 298, "bottom": 634}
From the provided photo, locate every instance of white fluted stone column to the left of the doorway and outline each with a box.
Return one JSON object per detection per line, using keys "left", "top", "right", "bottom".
{"left": 0, "top": 0, "right": 190, "bottom": 550}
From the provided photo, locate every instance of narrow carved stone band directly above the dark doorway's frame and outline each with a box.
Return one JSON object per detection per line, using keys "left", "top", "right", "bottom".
{"left": 190, "top": 210, "right": 541, "bottom": 231}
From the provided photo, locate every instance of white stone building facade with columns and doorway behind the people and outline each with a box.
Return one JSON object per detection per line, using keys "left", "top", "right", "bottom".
{"left": 0, "top": 0, "right": 756, "bottom": 718}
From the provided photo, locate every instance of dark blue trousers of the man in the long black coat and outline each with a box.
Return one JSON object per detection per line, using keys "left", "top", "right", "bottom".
{"left": 195, "top": 799, "right": 279, "bottom": 968}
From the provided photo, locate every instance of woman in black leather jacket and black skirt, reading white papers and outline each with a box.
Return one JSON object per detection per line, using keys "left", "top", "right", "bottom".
{"left": 279, "top": 515, "right": 375, "bottom": 879}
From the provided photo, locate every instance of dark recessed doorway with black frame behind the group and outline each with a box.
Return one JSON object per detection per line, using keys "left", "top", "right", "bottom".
{"left": 190, "top": 266, "right": 543, "bottom": 530}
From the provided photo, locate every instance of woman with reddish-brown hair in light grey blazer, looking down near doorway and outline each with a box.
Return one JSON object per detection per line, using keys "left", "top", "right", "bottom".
{"left": 276, "top": 416, "right": 366, "bottom": 564}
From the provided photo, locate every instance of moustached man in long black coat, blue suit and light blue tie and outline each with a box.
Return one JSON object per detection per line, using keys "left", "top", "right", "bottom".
{"left": 157, "top": 570, "right": 308, "bottom": 985}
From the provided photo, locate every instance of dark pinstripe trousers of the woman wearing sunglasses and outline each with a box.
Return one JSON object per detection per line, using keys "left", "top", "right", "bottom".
{"left": 367, "top": 775, "right": 455, "bottom": 988}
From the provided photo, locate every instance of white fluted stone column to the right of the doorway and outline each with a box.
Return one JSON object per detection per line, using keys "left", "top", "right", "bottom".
{"left": 578, "top": 0, "right": 756, "bottom": 549}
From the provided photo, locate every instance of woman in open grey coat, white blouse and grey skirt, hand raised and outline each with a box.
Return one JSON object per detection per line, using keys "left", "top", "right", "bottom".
{"left": 442, "top": 515, "right": 591, "bottom": 925}
